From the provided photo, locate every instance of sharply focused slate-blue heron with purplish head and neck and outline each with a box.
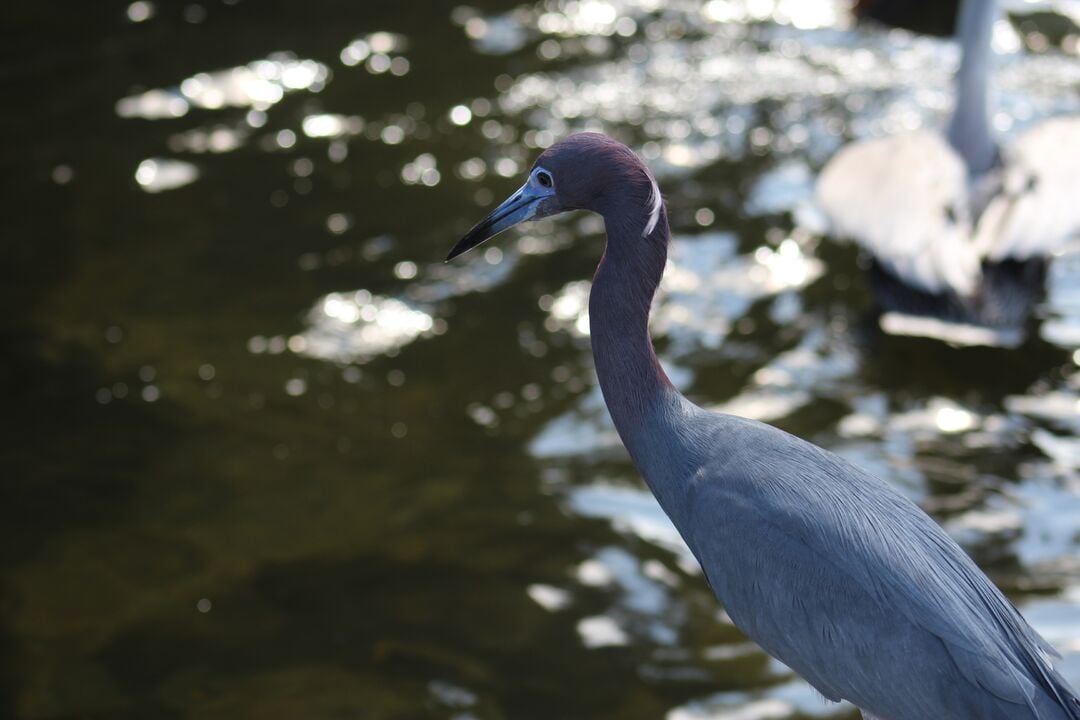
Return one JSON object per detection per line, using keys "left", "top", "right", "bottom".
{"left": 447, "top": 133, "right": 1080, "bottom": 720}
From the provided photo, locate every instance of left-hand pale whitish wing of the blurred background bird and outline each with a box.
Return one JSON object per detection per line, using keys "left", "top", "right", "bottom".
{"left": 816, "top": 131, "right": 981, "bottom": 296}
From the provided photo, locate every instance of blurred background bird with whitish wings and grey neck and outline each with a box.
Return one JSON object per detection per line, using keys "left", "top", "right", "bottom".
{"left": 818, "top": 0, "right": 1080, "bottom": 347}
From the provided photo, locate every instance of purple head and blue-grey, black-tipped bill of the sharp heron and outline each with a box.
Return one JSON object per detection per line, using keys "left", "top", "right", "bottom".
{"left": 446, "top": 133, "right": 662, "bottom": 260}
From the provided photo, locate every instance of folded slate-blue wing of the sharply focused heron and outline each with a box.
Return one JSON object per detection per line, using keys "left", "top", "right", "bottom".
{"left": 688, "top": 418, "right": 1080, "bottom": 718}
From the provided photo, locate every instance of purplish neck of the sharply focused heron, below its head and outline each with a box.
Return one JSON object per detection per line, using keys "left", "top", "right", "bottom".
{"left": 589, "top": 202, "right": 687, "bottom": 496}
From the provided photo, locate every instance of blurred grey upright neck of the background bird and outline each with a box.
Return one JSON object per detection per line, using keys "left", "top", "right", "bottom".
{"left": 948, "top": 0, "right": 998, "bottom": 175}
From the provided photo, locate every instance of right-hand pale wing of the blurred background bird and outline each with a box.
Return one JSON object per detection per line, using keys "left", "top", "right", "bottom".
{"left": 975, "top": 118, "right": 1080, "bottom": 260}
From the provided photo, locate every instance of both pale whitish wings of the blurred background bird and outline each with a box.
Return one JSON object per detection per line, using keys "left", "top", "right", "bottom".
{"left": 818, "top": 118, "right": 1080, "bottom": 296}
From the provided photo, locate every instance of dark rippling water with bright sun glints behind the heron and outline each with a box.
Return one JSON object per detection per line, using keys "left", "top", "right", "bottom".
{"left": 6, "top": 0, "right": 1080, "bottom": 720}
